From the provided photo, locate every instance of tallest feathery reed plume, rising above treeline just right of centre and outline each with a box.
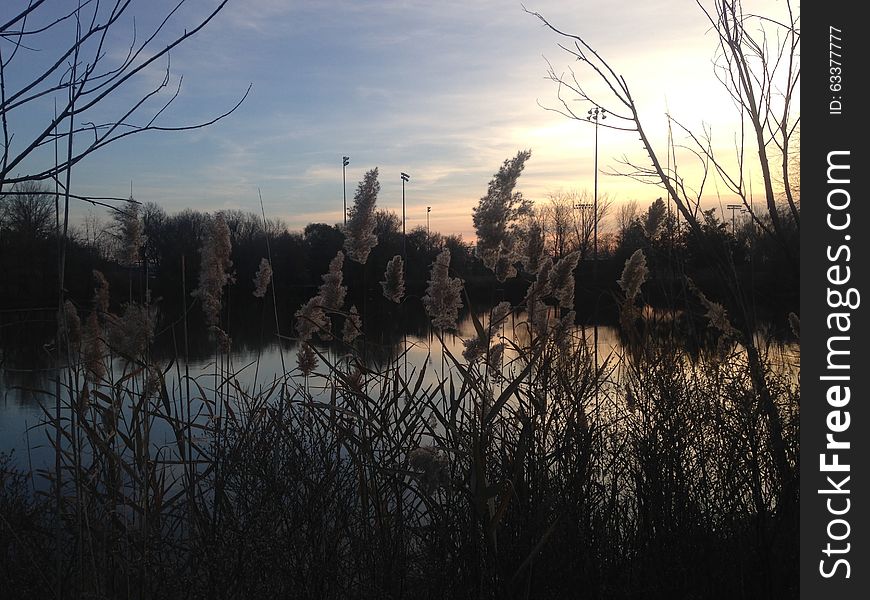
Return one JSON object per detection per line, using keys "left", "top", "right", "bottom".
{"left": 472, "top": 150, "right": 532, "bottom": 281}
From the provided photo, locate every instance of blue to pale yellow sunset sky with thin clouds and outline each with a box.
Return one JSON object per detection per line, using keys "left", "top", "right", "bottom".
{"left": 0, "top": 0, "right": 796, "bottom": 241}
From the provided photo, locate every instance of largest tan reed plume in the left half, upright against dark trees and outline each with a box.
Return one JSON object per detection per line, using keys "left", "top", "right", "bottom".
{"left": 191, "top": 213, "right": 234, "bottom": 326}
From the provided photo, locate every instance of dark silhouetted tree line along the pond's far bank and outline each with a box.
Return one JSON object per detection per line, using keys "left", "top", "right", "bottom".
{"left": 0, "top": 184, "right": 799, "bottom": 338}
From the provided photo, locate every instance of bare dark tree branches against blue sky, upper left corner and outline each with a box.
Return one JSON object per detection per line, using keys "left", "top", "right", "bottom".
{"left": 0, "top": 0, "right": 250, "bottom": 189}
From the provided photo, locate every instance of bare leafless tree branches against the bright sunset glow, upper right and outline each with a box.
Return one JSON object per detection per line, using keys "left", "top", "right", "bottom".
{"left": 529, "top": 0, "right": 800, "bottom": 250}
